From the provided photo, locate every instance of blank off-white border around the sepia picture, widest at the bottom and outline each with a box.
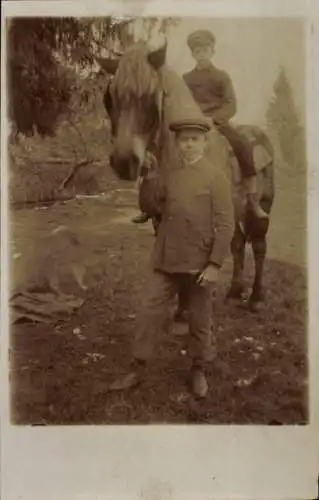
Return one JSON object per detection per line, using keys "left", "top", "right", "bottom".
{"left": 1, "top": 0, "right": 319, "bottom": 500}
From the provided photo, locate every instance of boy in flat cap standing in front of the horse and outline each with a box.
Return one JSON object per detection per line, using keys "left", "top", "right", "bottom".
{"left": 111, "top": 117, "right": 233, "bottom": 398}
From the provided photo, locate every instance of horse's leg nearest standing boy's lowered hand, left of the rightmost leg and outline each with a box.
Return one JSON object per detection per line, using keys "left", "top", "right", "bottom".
{"left": 227, "top": 222, "right": 246, "bottom": 299}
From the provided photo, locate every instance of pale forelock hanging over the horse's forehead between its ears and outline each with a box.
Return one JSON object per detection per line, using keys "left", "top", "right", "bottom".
{"left": 113, "top": 42, "right": 158, "bottom": 103}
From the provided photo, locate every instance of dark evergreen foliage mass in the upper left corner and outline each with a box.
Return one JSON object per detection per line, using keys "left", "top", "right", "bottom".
{"left": 7, "top": 19, "right": 75, "bottom": 136}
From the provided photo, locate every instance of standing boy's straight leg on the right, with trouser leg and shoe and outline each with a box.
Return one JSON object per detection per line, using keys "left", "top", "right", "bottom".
{"left": 188, "top": 276, "right": 216, "bottom": 397}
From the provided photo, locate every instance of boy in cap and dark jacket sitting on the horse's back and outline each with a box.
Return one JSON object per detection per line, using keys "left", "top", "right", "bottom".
{"left": 184, "top": 30, "right": 268, "bottom": 219}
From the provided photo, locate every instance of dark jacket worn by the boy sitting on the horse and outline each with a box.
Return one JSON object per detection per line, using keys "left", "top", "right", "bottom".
{"left": 183, "top": 64, "right": 237, "bottom": 124}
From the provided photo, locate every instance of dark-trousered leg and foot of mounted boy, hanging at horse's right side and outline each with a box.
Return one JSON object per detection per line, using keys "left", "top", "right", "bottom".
{"left": 218, "top": 125, "right": 268, "bottom": 219}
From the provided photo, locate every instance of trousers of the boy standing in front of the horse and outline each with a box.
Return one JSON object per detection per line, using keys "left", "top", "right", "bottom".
{"left": 133, "top": 271, "right": 216, "bottom": 366}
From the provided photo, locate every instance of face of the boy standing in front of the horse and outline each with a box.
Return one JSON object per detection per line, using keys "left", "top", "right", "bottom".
{"left": 176, "top": 129, "right": 206, "bottom": 163}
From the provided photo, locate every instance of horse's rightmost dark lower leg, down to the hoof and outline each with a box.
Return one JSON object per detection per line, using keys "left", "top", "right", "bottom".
{"left": 249, "top": 236, "right": 267, "bottom": 311}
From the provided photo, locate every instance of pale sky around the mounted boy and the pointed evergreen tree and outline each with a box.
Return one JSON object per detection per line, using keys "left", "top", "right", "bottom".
{"left": 162, "top": 18, "right": 306, "bottom": 125}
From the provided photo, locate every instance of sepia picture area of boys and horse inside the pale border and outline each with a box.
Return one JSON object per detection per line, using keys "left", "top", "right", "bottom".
{"left": 6, "top": 11, "right": 309, "bottom": 426}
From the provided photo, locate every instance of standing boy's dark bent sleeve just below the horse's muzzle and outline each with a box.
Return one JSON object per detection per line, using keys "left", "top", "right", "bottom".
{"left": 139, "top": 172, "right": 165, "bottom": 217}
